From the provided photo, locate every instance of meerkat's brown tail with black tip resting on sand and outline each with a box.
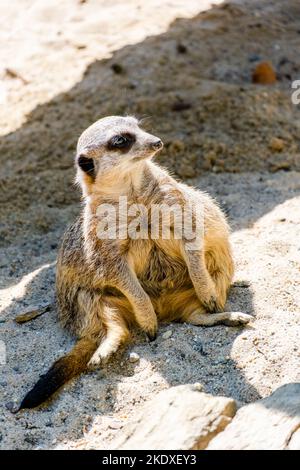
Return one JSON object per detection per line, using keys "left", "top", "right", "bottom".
{"left": 19, "top": 337, "right": 99, "bottom": 410}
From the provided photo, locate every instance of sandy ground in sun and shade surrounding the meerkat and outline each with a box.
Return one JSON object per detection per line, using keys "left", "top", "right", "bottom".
{"left": 0, "top": 0, "right": 300, "bottom": 449}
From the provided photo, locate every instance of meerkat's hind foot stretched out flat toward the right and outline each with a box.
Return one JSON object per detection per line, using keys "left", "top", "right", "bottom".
{"left": 185, "top": 310, "right": 253, "bottom": 326}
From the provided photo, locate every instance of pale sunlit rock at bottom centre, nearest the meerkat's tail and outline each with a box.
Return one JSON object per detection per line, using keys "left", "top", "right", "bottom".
{"left": 111, "top": 384, "right": 236, "bottom": 450}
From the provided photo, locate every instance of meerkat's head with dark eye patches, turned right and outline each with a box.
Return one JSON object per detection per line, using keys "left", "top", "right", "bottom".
{"left": 76, "top": 116, "right": 163, "bottom": 191}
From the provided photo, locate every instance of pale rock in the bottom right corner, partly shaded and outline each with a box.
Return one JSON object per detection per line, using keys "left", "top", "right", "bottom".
{"left": 207, "top": 383, "right": 300, "bottom": 450}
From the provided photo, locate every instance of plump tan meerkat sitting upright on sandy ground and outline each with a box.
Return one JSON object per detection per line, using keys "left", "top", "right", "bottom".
{"left": 20, "top": 116, "right": 252, "bottom": 409}
